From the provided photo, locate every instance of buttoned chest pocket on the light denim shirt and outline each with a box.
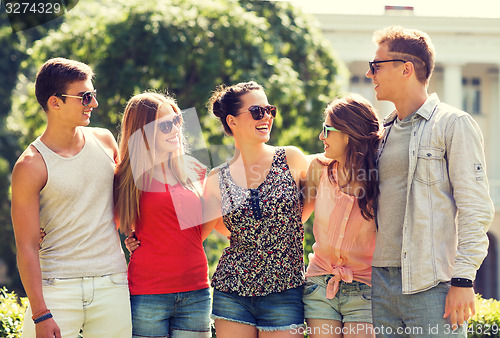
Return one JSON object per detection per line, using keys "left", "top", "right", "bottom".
{"left": 415, "top": 147, "right": 445, "bottom": 185}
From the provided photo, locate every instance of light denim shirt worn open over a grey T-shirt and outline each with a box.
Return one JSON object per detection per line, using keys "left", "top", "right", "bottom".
{"left": 379, "top": 94, "right": 494, "bottom": 294}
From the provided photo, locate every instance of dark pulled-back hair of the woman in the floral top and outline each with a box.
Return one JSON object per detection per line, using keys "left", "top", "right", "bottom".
{"left": 207, "top": 81, "right": 264, "bottom": 135}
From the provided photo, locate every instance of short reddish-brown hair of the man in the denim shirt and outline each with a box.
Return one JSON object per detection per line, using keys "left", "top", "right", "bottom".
{"left": 373, "top": 26, "right": 436, "bottom": 83}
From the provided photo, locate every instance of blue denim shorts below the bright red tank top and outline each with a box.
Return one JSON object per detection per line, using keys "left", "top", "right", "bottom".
{"left": 130, "top": 288, "right": 210, "bottom": 338}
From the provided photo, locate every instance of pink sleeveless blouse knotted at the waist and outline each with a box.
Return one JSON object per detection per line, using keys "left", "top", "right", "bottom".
{"left": 306, "top": 166, "right": 376, "bottom": 299}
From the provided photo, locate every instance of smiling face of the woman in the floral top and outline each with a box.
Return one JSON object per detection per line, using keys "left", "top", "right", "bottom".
{"left": 227, "top": 90, "right": 274, "bottom": 143}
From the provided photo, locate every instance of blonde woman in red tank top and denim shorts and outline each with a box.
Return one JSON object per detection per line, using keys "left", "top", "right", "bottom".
{"left": 115, "top": 92, "right": 210, "bottom": 338}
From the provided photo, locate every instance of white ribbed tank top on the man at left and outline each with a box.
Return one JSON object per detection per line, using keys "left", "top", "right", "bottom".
{"left": 32, "top": 127, "right": 127, "bottom": 279}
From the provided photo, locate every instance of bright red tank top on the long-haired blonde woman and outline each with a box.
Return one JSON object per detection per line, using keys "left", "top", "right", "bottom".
{"left": 128, "top": 180, "right": 209, "bottom": 295}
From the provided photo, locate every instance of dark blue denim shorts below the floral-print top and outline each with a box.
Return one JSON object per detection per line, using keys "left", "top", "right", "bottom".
{"left": 212, "top": 286, "right": 304, "bottom": 331}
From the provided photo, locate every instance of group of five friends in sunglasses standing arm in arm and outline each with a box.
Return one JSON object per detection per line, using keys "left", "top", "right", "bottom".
{"left": 12, "top": 26, "right": 494, "bottom": 338}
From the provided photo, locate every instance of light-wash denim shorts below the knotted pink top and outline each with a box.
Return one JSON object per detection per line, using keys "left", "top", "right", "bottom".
{"left": 303, "top": 275, "right": 372, "bottom": 323}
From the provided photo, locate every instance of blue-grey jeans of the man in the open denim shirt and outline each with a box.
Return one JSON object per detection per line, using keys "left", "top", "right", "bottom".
{"left": 372, "top": 267, "right": 466, "bottom": 338}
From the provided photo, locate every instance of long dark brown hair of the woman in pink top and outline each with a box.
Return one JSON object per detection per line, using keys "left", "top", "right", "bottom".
{"left": 325, "top": 94, "right": 381, "bottom": 219}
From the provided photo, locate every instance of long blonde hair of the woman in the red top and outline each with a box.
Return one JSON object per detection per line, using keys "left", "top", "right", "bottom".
{"left": 114, "top": 92, "right": 201, "bottom": 235}
